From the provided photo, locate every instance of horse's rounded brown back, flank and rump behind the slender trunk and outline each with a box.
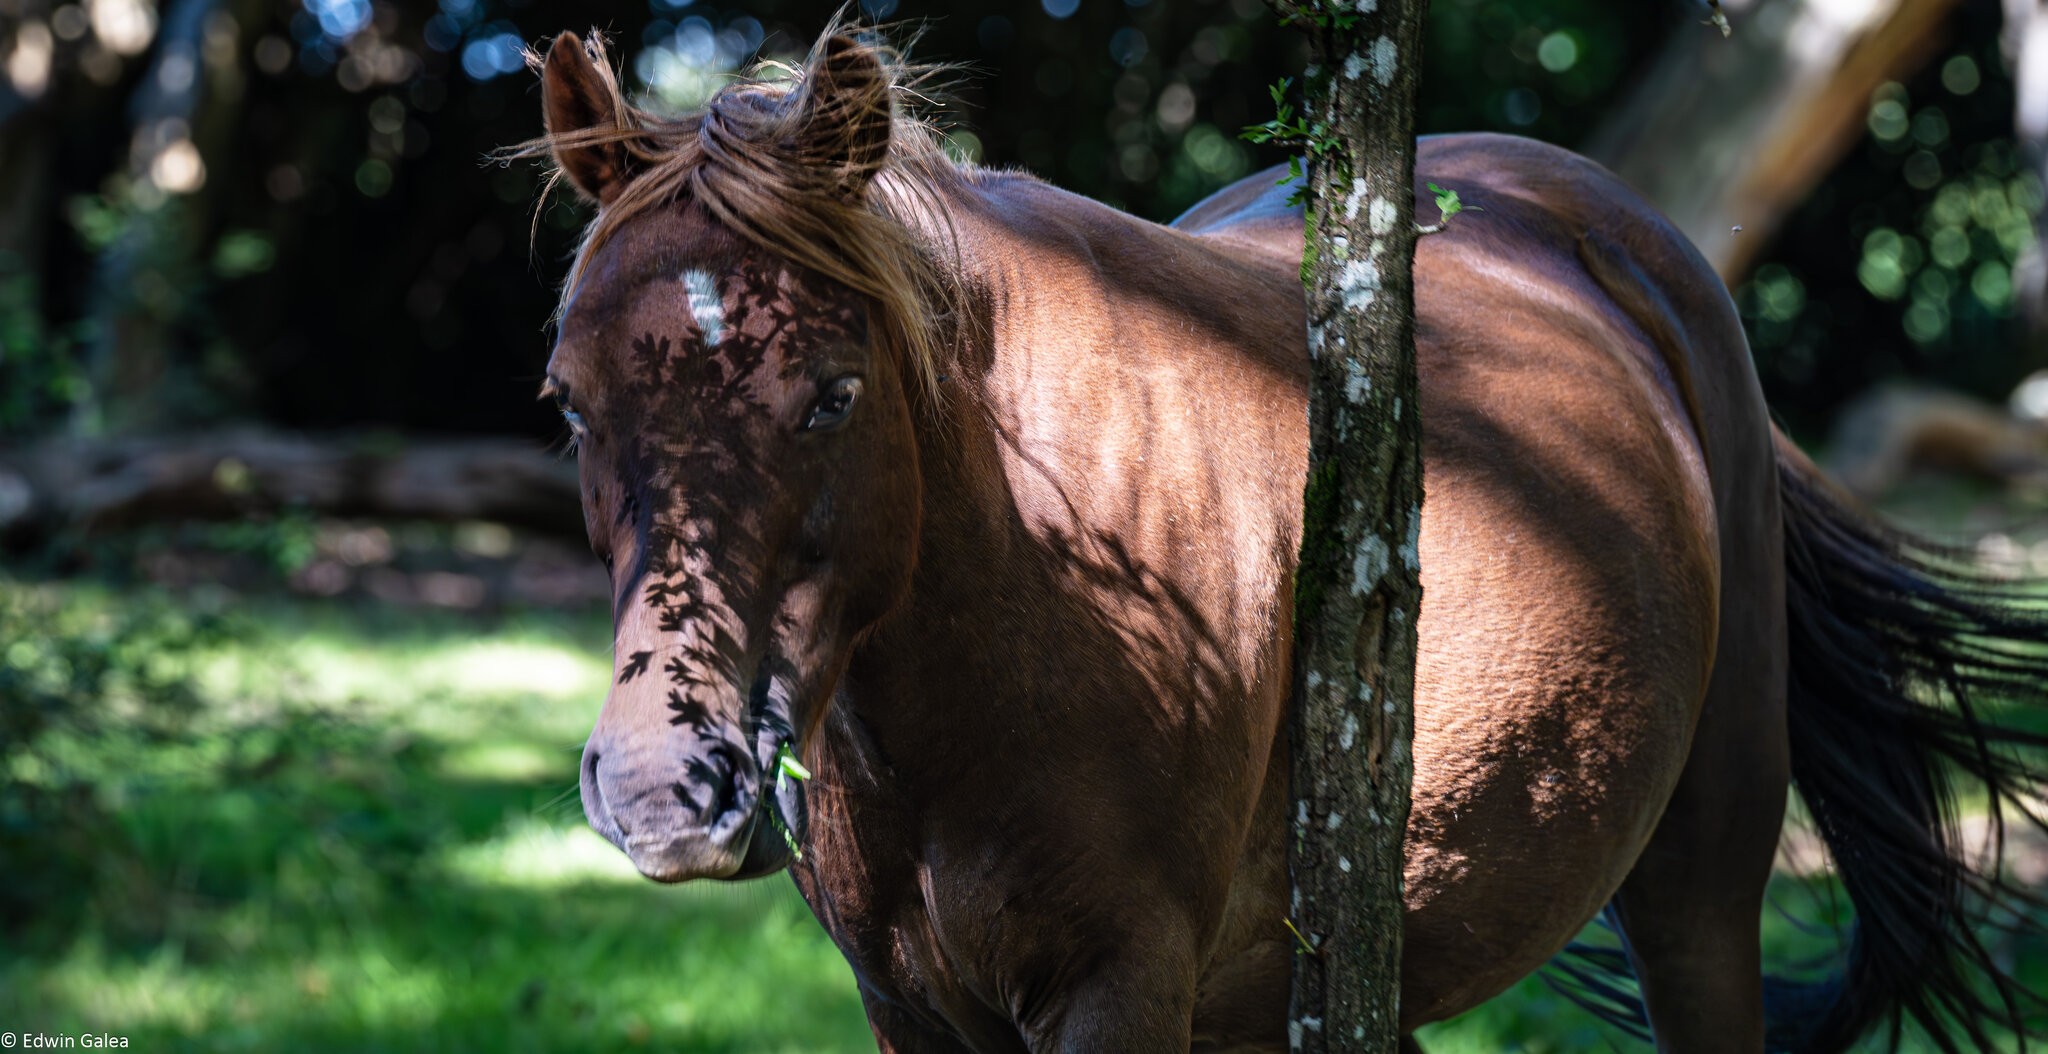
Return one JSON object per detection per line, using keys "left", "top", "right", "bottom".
{"left": 1176, "top": 135, "right": 1774, "bottom": 1023}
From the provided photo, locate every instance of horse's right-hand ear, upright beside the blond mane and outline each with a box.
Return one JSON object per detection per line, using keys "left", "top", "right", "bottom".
{"left": 797, "top": 33, "right": 891, "bottom": 199}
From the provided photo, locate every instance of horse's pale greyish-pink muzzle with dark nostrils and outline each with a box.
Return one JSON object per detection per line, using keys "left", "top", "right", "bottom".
{"left": 582, "top": 741, "right": 760, "bottom": 882}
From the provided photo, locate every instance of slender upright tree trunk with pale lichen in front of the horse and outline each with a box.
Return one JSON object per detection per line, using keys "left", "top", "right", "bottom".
{"left": 1282, "top": 0, "right": 1425, "bottom": 1054}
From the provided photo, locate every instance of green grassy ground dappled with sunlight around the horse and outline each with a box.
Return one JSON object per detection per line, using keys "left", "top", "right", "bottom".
{"left": 0, "top": 480, "right": 2048, "bottom": 1054}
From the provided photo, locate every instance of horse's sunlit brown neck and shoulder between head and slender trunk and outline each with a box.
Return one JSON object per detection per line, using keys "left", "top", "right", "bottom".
{"left": 848, "top": 182, "right": 1303, "bottom": 794}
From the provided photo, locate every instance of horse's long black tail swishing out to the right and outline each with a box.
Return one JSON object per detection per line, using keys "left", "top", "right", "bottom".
{"left": 1548, "top": 436, "right": 2048, "bottom": 1054}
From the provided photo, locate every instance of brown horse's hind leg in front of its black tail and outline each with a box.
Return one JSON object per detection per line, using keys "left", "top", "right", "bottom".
{"left": 1614, "top": 536, "right": 1790, "bottom": 1052}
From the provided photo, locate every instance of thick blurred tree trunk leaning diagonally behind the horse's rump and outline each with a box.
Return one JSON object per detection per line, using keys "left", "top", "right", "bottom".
{"left": 1585, "top": 0, "right": 1956, "bottom": 284}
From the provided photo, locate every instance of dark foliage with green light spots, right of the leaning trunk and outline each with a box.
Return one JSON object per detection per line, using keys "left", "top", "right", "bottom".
{"left": 1737, "top": 4, "right": 2048, "bottom": 432}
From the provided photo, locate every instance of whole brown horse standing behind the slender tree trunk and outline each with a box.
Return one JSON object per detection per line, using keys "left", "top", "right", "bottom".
{"left": 537, "top": 24, "right": 2048, "bottom": 1052}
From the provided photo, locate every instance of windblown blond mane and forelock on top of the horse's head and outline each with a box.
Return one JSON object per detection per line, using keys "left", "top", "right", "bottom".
{"left": 524, "top": 25, "right": 971, "bottom": 397}
